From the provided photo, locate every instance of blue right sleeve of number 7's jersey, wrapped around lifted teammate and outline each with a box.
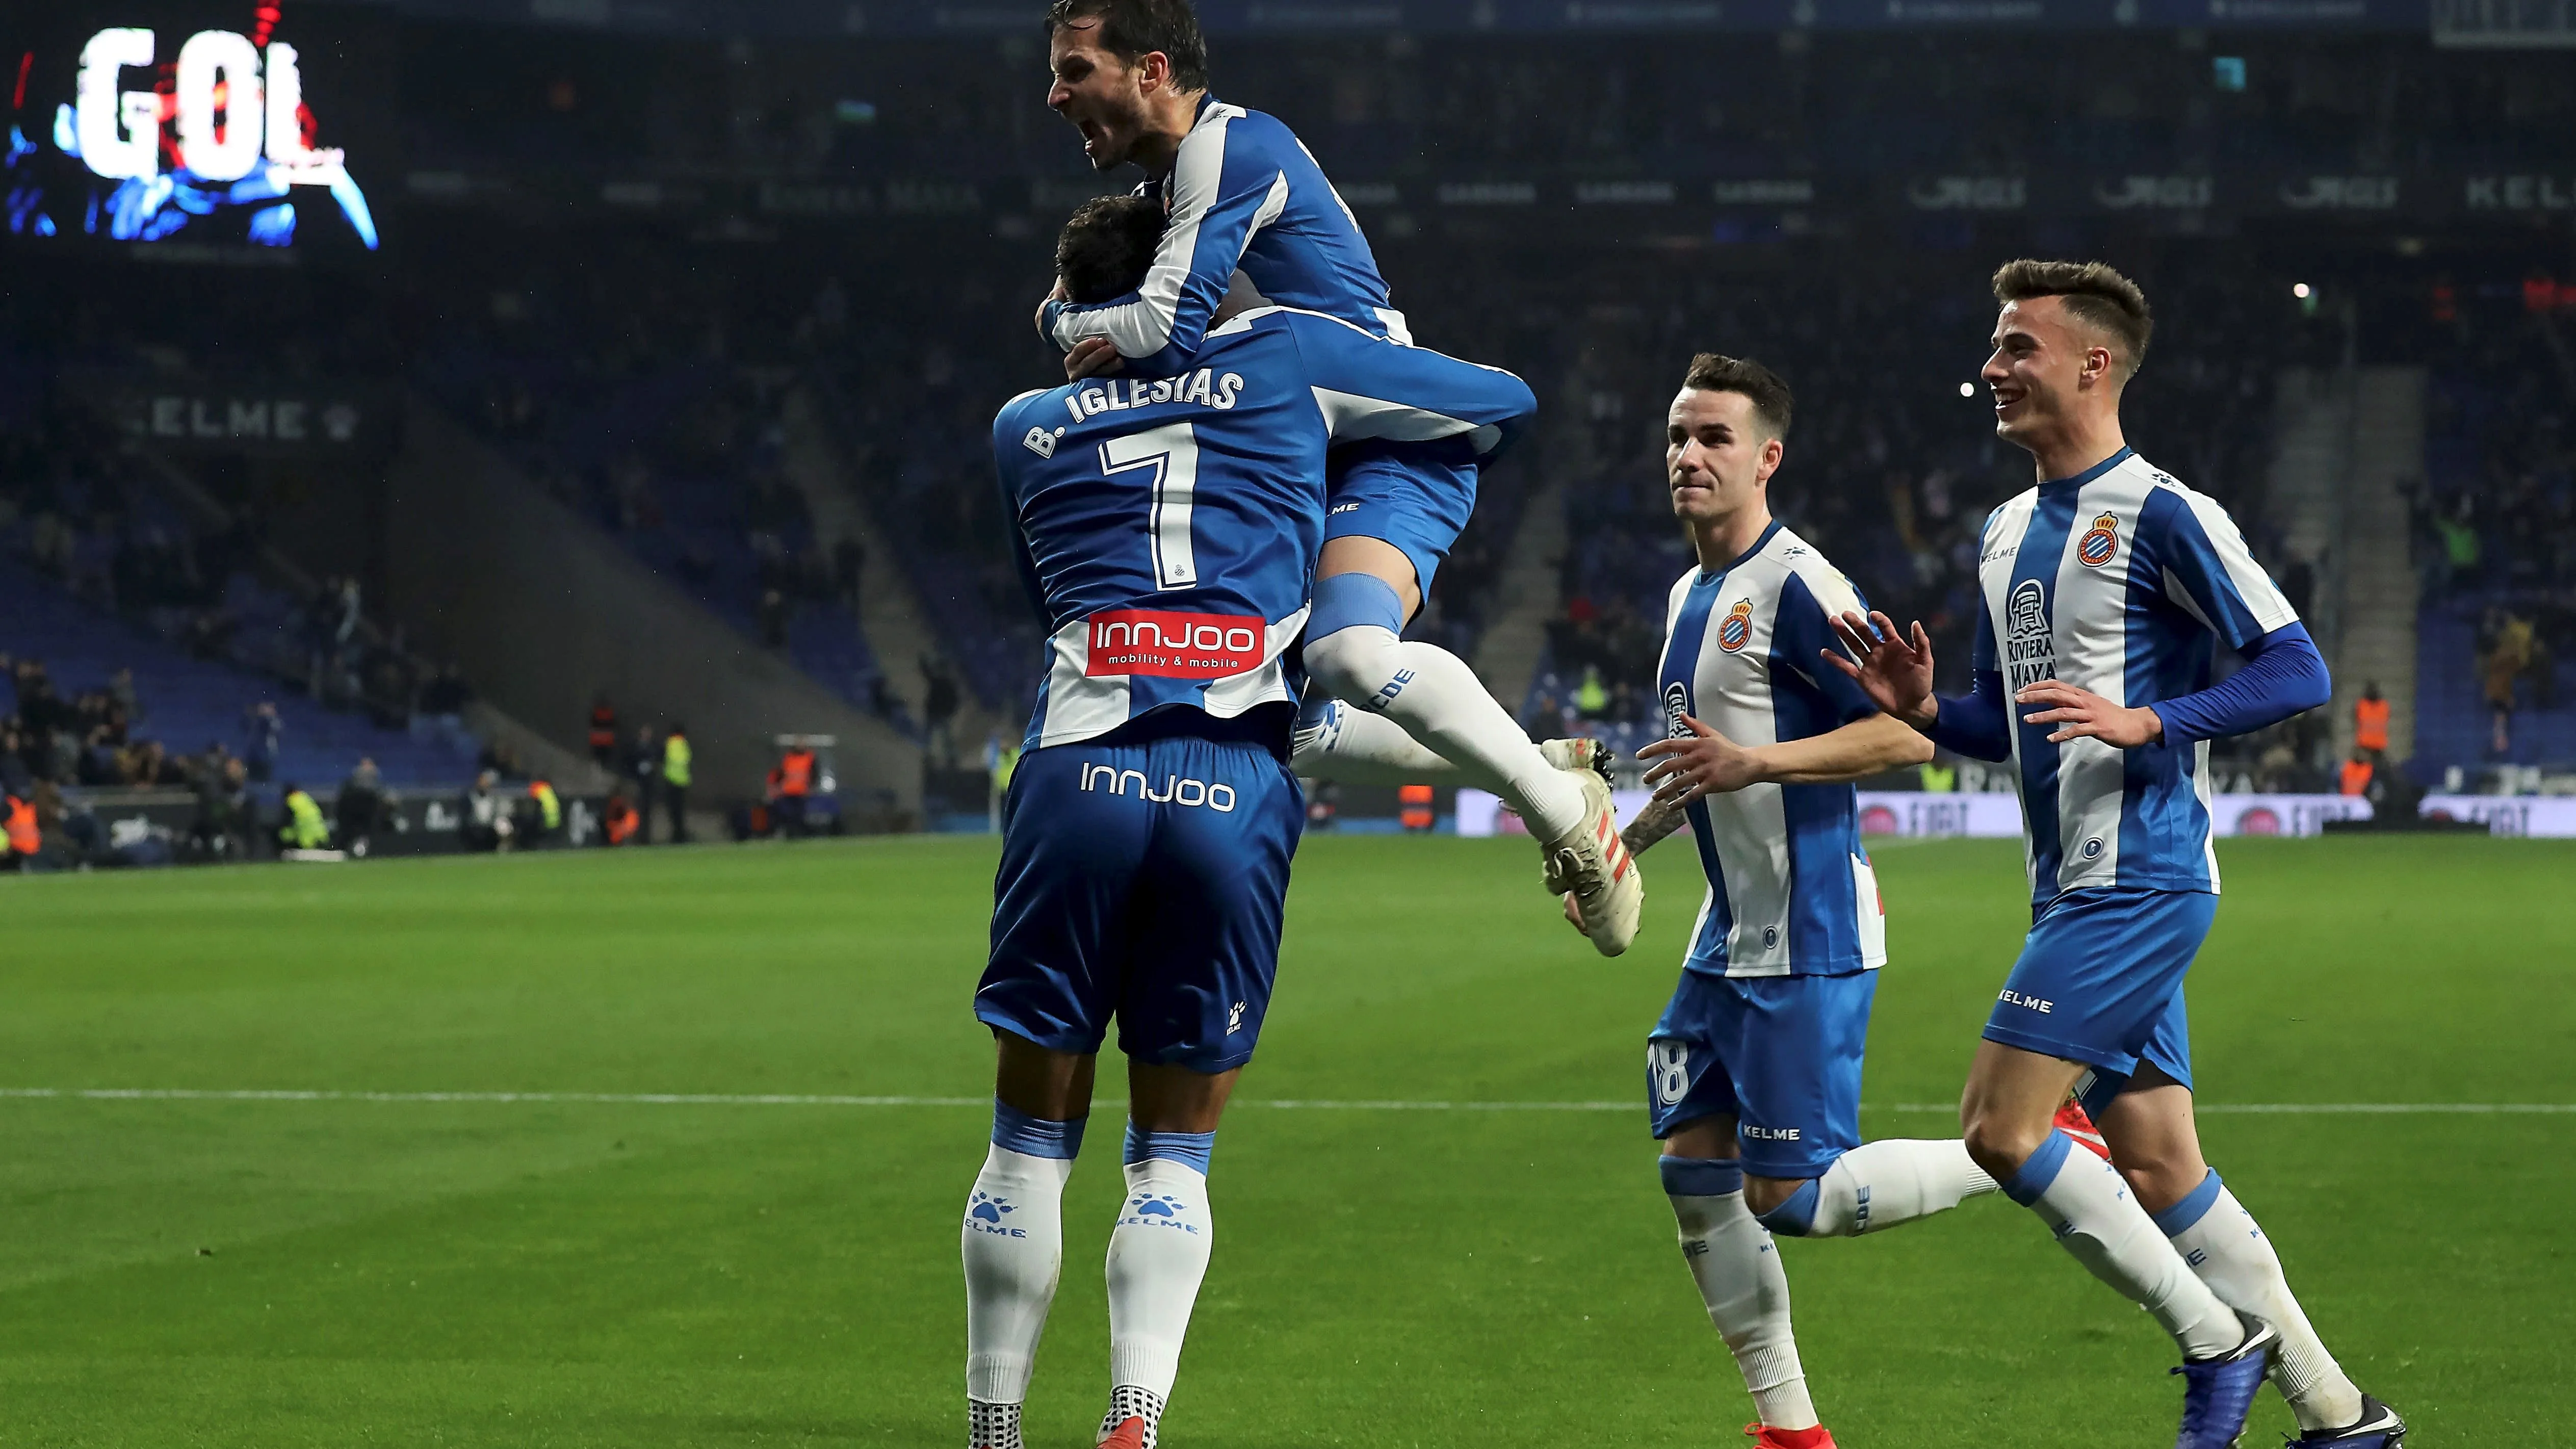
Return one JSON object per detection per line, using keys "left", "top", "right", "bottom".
{"left": 1267, "top": 312, "right": 1538, "bottom": 461}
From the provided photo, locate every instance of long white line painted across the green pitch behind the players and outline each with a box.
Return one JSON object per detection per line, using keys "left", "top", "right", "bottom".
{"left": 0, "top": 1088, "right": 2576, "bottom": 1117}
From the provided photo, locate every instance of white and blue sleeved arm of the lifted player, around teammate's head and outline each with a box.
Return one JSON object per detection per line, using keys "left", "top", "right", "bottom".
{"left": 1046, "top": 103, "right": 1293, "bottom": 376}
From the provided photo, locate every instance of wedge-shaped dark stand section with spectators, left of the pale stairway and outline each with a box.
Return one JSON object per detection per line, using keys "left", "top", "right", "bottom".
{"left": 409, "top": 224, "right": 909, "bottom": 727}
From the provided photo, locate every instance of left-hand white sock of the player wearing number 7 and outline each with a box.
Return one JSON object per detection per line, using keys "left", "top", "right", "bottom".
{"left": 958, "top": 1147, "right": 1074, "bottom": 1413}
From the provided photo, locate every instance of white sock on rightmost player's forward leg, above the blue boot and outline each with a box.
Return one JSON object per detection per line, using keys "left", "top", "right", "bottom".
{"left": 2004, "top": 1132, "right": 2246, "bottom": 1359}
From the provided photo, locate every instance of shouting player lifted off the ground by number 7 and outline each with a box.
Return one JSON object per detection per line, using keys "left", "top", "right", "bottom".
{"left": 1038, "top": 0, "right": 1644, "bottom": 956}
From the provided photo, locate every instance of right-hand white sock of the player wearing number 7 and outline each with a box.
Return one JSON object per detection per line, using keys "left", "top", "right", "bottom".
{"left": 1103, "top": 1158, "right": 1216, "bottom": 1449}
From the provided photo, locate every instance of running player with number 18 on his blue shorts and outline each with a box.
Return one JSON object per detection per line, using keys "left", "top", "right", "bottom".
{"left": 1569, "top": 353, "right": 1994, "bottom": 1449}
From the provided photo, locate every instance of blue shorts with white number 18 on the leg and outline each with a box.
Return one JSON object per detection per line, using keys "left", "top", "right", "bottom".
{"left": 1646, "top": 972, "right": 1878, "bottom": 1178}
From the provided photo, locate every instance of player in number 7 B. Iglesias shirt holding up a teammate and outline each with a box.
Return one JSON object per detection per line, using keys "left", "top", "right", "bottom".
{"left": 961, "top": 196, "right": 1536, "bottom": 1449}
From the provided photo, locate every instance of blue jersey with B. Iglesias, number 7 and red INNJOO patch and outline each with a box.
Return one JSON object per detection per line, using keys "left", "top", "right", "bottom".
{"left": 992, "top": 307, "right": 1538, "bottom": 751}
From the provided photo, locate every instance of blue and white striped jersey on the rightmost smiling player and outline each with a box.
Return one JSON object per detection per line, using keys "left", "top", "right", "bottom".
{"left": 1976, "top": 449, "right": 2298, "bottom": 905}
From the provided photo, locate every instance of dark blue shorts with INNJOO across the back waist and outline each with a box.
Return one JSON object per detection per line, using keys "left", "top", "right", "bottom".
{"left": 974, "top": 737, "right": 1306, "bottom": 1073}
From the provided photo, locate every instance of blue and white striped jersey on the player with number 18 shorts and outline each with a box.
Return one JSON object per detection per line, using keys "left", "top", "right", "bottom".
{"left": 1659, "top": 513, "right": 1888, "bottom": 977}
